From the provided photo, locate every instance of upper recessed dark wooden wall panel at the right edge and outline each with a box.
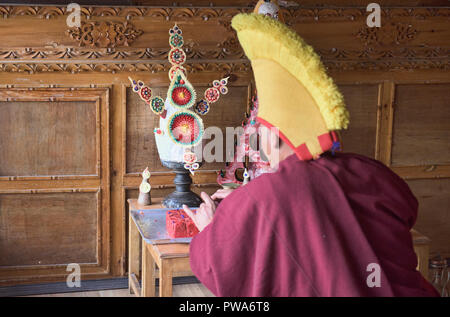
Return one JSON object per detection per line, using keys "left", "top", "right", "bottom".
{"left": 392, "top": 83, "right": 450, "bottom": 166}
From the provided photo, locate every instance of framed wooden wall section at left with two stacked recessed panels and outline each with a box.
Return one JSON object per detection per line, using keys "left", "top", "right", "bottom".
{"left": 0, "top": 85, "right": 111, "bottom": 284}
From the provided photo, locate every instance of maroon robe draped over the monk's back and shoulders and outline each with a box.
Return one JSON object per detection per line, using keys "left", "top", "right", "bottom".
{"left": 190, "top": 153, "right": 438, "bottom": 296}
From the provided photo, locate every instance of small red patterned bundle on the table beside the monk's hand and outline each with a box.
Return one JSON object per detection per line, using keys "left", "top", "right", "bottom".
{"left": 166, "top": 209, "right": 199, "bottom": 238}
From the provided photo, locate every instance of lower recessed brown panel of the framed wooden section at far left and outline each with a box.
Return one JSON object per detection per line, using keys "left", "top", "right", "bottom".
{"left": 0, "top": 193, "right": 100, "bottom": 266}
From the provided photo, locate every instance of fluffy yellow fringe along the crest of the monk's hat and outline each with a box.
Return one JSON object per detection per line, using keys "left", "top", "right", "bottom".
{"left": 231, "top": 13, "right": 349, "bottom": 130}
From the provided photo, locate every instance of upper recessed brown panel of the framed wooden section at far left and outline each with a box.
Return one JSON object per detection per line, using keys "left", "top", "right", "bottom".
{"left": 0, "top": 101, "right": 97, "bottom": 176}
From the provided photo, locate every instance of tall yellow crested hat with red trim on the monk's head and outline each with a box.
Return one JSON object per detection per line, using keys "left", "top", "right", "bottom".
{"left": 232, "top": 13, "right": 349, "bottom": 160}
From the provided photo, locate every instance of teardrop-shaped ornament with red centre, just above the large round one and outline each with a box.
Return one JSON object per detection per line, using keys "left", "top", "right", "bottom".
{"left": 167, "top": 70, "right": 197, "bottom": 109}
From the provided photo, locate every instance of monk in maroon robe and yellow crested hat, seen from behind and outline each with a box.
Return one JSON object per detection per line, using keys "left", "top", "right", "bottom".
{"left": 183, "top": 14, "right": 438, "bottom": 297}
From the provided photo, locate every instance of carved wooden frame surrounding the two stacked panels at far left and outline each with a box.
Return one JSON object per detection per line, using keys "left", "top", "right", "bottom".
{"left": 0, "top": 86, "right": 111, "bottom": 284}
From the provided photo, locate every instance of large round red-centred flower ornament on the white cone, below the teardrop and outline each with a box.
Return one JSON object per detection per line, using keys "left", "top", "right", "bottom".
{"left": 167, "top": 110, "right": 204, "bottom": 146}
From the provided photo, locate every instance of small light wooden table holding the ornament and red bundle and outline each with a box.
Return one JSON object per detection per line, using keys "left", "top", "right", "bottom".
{"left": 128, "top": 199, "right": 193, "bottom": 297}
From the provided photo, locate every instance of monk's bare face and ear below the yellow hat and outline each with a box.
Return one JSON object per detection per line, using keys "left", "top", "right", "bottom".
{"left": 259, "top": 124, "right": 294, "bottom": 168}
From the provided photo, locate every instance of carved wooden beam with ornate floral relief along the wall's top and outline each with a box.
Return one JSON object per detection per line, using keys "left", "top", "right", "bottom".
{"left": 0, "top": 6, "right": 450, "bottom": 73}
